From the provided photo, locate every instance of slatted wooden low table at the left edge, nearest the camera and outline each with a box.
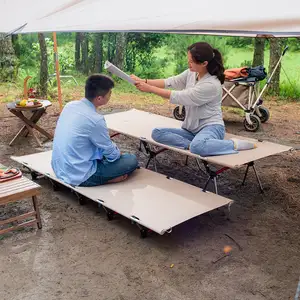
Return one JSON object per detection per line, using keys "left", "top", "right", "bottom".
{"left": 0, "top": 176, "right": 42, "bottom": 234}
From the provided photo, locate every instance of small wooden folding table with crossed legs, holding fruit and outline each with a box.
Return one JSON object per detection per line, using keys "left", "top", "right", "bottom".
{"left": 7, "top": 100, "right": 53, "bottom": 147}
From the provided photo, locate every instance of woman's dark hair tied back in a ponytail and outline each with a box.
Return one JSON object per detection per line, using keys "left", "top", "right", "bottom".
{"left": 187, "top": 42, "right": 225, "bottom": 84}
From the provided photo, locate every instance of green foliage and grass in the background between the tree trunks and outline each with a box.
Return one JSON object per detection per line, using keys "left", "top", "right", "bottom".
{"left": 4, "top": 33, "right": 300, "bottom": 99}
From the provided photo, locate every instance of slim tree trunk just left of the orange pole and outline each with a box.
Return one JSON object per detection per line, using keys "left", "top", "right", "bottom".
{"left": 38, "top": 33, "right": 48, "bottom": 97}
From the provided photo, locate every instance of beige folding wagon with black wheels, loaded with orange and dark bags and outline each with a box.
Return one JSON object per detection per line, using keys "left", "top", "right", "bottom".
{"left": 173, "top": 47, "right": 288, "bottom": 132}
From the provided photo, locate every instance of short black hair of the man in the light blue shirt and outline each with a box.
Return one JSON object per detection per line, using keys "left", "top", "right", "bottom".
{"left": 85, "top": 74, "right": 115, "bottom": 101}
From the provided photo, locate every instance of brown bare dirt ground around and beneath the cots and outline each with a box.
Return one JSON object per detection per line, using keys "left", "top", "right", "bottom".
{"left": 0, "top": 102, "right": 300, "bottom": 300}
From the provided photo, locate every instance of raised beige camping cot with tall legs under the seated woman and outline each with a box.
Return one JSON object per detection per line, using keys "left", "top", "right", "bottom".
{"left": 105, "top": 109, "right": 292, "bottom": 193}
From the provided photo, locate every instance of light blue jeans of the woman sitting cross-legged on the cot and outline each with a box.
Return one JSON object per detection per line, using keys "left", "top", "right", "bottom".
{"left": 152, "top": 124, "right": 238, "bottom": 157}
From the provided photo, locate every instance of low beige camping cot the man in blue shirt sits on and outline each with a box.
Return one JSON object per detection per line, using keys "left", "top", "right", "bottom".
{"left": 11, "top": 150, "right": 233, "bottom": 238}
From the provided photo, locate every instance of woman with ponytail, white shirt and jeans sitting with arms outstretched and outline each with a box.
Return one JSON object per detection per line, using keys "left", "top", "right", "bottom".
{"left": 131, "top": 42, "right": 256, "bottom": 157}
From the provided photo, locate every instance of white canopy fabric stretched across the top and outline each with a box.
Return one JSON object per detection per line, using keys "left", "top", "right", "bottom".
{"left": 0, "top": 0, "right": 300, "bottom": 37}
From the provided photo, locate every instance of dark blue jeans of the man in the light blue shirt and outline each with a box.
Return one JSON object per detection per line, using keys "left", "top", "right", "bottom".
{"left": 80, "top": 154, "right": 138, "bottom": 186}
